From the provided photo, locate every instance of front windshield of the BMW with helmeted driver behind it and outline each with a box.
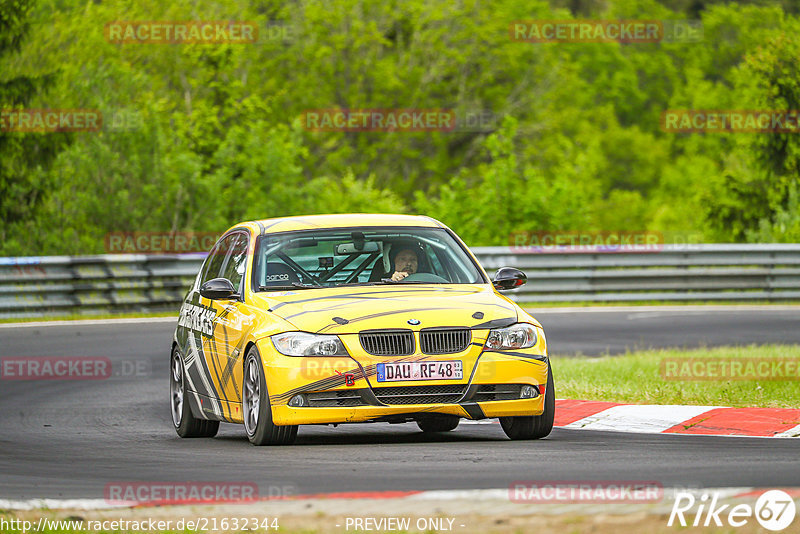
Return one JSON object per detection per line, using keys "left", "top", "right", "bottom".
{"left": 253, "top": 227, "right": 486, "bottom": 291}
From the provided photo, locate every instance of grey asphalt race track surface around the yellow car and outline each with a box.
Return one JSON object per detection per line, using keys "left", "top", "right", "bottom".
{"left": 0, "top": 307, "right": 800, "bottom": 499}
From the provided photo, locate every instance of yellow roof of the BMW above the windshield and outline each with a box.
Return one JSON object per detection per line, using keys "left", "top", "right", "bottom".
{"left": 234, "top": 213, "right": 446, "bottom": 234}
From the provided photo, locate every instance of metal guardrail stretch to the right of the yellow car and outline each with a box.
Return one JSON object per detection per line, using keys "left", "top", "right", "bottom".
{"left": 475, "top": 244, "right": 800, "bottom": 302}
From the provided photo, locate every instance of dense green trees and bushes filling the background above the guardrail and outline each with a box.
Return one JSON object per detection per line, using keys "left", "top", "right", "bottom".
{"left": 0, "top": 0, "right": 800, "bottom": 255}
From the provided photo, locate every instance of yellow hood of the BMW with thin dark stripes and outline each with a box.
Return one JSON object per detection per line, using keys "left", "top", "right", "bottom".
{"left": 254, "top": 284, "right": 517, "bottom": 334}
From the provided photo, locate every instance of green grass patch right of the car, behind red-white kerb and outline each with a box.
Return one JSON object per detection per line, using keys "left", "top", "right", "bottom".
{"left": 552, "top": 345, "right": 800, "bottom": 408}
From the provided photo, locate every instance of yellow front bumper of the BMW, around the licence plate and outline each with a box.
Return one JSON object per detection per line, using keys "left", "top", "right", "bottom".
{"left": 259, "top": 343, "right": 548, "bottom": 425}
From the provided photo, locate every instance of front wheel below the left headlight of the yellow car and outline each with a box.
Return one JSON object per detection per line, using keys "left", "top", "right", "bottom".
{"left": 242, "top": 347, "right": 297, "bottom": 446}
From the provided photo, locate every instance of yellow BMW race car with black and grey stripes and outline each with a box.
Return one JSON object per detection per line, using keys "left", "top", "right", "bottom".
{"left": 170, "top": 214, "right": 555, "bottom": 445}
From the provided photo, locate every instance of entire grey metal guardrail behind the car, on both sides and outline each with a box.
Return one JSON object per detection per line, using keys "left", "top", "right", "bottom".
{"left": 0, "top": 244, "right": 800, "bottom": 318}
